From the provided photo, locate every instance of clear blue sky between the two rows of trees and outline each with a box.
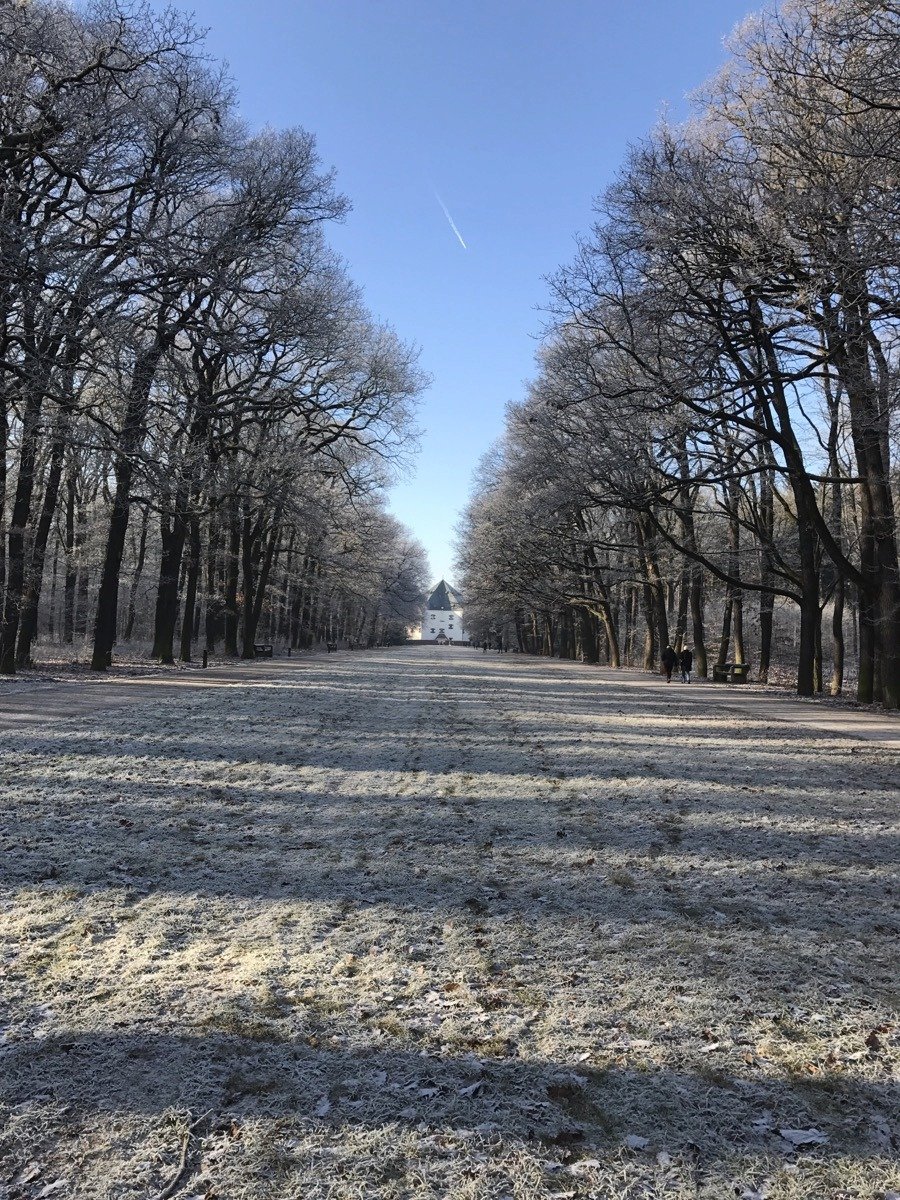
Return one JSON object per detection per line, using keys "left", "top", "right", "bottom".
{"left": 160, "top": 0, "right": 755, "bottom": 580}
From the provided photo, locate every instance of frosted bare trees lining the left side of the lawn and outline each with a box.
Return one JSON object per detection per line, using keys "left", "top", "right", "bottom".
{"left": 0, "top": 0, "right": 426, "bottom": 672}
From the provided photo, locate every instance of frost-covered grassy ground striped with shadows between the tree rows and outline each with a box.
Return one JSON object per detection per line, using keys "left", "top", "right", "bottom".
{"left": 0, "top": 648, "right": 900, "bottom": 1200}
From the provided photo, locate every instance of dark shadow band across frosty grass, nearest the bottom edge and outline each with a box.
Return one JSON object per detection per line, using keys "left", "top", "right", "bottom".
{"left": 0, "top": 1015, "right": 900, "bottom": 1158}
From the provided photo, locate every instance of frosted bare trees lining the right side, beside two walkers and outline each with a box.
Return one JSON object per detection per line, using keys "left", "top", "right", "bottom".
{"left": 462, "top": 0, "right": 900, "bottom": 708}
